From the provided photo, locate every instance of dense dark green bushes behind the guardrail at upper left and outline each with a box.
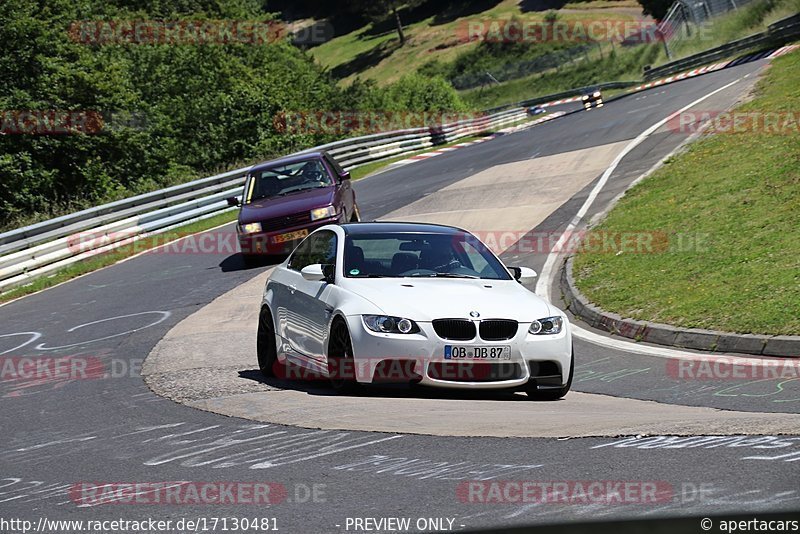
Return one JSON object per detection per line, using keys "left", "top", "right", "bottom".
{"left": 0, "top": 0, "right": 341, "bottom": 228}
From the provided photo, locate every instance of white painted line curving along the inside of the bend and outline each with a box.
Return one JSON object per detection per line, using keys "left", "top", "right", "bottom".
{"left": 535, "top": 77, "right": 752, "bottom": 364}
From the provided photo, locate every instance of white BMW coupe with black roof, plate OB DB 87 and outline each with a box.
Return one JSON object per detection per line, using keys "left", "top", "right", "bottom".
{"left": 258, "top": 222, "right": 574, "bottom": 400}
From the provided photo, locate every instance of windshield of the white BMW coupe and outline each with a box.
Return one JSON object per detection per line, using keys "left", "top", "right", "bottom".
{"left": 344, "top": 232, "right": 511, "bottom": 280}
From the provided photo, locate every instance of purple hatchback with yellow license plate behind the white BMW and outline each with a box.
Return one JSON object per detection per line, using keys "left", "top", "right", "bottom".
{"left": 228, "top": 152, "right": 360, "bottom": 262}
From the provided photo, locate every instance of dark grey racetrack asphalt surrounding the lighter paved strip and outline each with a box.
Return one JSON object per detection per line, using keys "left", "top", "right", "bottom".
{"left": 0, "top": 56, "right": 800, "bottom": 532}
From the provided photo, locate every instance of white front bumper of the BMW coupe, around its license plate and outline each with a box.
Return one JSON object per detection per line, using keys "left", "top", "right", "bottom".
{"left": 347, "top": 315, "right": 572, "bottom": 389}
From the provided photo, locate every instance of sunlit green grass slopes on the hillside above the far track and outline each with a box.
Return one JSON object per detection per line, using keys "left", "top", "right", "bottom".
{"left": 310, "top": 0, "right": 800, "bottom": 113}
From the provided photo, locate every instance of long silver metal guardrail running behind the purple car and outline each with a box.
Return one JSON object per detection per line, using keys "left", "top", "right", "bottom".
{"left": 0, "top": 108, "right": 527, "bottom": 292}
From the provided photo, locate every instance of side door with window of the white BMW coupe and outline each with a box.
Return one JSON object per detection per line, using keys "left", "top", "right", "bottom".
{"left": 286, "top": 230, "right": 337, "bottom": 361}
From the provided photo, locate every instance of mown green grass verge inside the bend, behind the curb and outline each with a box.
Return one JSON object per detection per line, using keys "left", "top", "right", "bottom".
{"left": 575, "top": 48, "right": 800, "bottom": 335}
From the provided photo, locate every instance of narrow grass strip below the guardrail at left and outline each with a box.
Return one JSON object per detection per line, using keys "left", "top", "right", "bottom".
{"left": 0, "top": 211, "right": 238, "bottom": 304}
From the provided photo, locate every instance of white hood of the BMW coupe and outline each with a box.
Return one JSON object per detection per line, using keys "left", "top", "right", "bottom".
{"left": 343, "top": 278, "right": 558, "bottom": 323}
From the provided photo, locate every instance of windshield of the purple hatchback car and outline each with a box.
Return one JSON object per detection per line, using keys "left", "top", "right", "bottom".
{"left": 247, "top": 159, "right": 333, "bottom": 202}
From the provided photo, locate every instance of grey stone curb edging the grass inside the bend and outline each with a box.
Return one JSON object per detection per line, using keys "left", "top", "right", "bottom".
{"left": 559, "top": 257, "right": 800, "bottom": 358}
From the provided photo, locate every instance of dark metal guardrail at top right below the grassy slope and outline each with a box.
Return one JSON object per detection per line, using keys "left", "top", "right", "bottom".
{"left": 644, "top": 14, "right": 800, "bottom": 81}
